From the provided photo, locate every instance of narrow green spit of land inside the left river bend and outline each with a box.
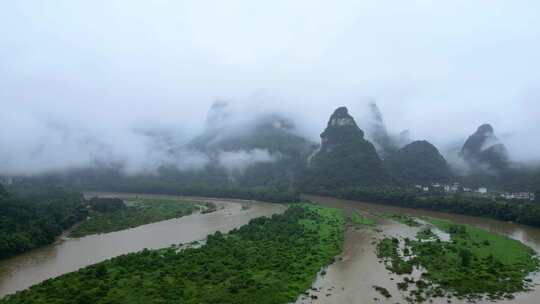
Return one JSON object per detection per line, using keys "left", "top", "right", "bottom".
{"left": 70, "top": 198, "right": 216, "bottom": 237}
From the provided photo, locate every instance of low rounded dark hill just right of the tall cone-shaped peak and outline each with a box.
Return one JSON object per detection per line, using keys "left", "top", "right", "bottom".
{"left": 385, "top": 140, "right": 452, "bottom": 184}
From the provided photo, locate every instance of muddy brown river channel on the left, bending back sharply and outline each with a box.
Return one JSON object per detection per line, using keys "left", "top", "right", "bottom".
{"left": 0, "top": 193, "right": 286, "bottom": 298}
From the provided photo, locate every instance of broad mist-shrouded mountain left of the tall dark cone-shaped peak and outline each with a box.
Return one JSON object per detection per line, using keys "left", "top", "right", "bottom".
{"left": 189, "top": 103, "right": 316, "bottom": 187}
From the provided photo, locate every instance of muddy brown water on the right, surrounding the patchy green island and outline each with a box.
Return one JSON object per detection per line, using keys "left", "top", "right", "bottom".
{"left": 296, "top": 196, "right": 540, "bottom": 304}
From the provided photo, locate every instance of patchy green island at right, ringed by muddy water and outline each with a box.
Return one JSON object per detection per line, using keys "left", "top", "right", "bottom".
{"left": 377, "top": 218, "right": 539, "bottom": 302}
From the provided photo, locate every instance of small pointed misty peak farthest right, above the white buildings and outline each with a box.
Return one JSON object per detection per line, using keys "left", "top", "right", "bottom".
{"left": 460, "top": 124, "right": 509, "bottom": 171}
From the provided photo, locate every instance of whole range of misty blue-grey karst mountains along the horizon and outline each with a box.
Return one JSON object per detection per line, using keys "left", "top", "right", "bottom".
{"left": 5, "top": 101, "right": 540, "bottom": 191}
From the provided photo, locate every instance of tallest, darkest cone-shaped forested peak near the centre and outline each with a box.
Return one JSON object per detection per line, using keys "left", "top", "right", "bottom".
{"left": 304, "top": 107, "right": 390, "bottom": 189}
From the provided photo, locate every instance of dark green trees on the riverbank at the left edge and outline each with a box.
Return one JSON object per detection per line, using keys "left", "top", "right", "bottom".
{"left": 0, "top": 187, "right": 86, "bottom": 259}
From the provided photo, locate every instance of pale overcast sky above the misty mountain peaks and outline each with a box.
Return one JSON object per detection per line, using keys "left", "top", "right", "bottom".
{"left": 0, "top": 0, "right": 540, "bottom": 173}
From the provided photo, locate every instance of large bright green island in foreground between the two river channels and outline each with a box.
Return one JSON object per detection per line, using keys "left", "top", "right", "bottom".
{"left": 0, "top": 204, "right": 345, "bottom": 304}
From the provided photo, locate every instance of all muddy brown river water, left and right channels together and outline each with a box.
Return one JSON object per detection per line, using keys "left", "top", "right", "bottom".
{"left": 0, "top": 193, "right": 540, "bottom": 304}
